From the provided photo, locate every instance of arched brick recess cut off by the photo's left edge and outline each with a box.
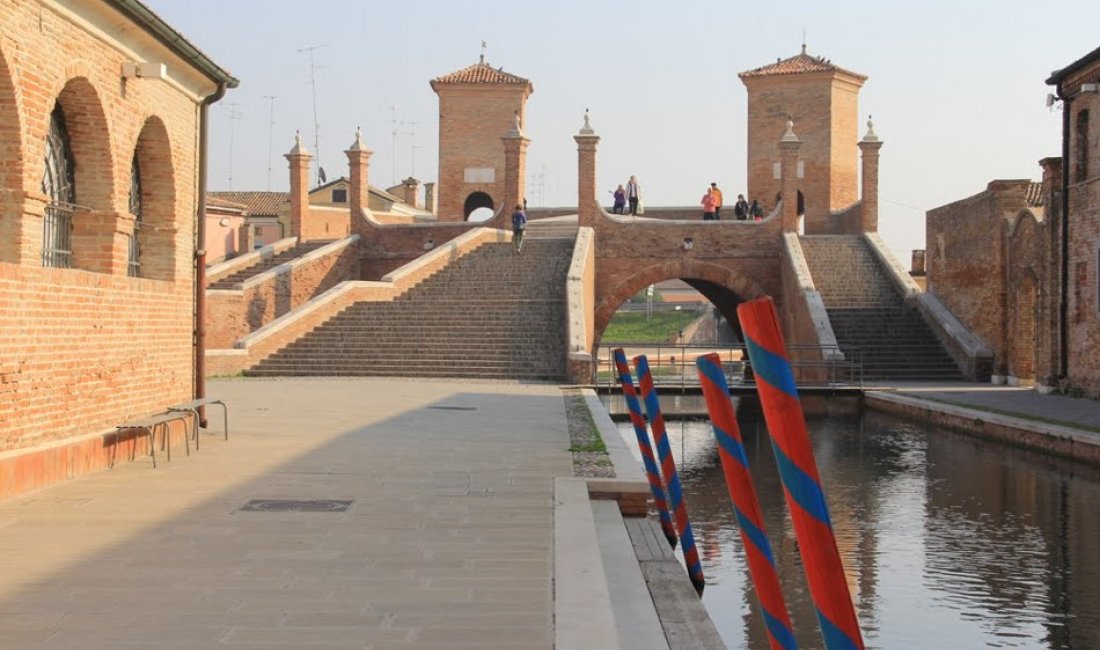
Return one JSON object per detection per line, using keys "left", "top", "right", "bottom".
{"left": 0, "top": 40, "right": 25, "bottom": 262}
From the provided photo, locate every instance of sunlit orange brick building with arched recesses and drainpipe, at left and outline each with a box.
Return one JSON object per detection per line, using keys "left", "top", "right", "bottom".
{"left": 0, "top": 0, "right": 237, "bottom": 495}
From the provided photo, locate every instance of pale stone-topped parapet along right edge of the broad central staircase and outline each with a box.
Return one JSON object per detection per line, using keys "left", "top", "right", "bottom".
{"left": 565, "top": 227, "right": 596, "bottom": 384}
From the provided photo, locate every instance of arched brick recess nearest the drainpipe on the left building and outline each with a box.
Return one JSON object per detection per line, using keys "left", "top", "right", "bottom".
{"left": 130, "top": 115, "right": 178, "bottom": 280}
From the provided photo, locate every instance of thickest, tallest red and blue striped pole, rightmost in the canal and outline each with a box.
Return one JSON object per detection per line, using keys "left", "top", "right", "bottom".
{"left": 737, "top": 297, "right": 864, "bottom": 650}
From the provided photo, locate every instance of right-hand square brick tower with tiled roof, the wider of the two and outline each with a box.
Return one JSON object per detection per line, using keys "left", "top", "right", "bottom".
{"left": 738, "top": 44, "right": 867, "bottom": 234}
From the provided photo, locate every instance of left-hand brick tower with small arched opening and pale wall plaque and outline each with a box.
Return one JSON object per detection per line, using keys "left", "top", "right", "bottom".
{"left": 431, "top": 54, "right": 535, "bottom": 221}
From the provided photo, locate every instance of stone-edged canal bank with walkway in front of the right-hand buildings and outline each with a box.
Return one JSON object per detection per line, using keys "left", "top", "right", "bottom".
{"left": 864, "top": 384, "right": 1100, "bottom": 465}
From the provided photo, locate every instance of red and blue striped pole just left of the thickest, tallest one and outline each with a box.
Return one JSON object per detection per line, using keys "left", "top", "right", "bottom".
{"left": 695, "top": 352, "right": 799, "bottom": 650}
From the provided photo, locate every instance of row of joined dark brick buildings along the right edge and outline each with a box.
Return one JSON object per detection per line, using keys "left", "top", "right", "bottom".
{"left": 925, "top": 48, "right": 1100, "bottom": 396}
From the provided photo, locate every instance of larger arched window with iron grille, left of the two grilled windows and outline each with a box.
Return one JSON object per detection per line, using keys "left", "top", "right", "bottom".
{"left": 42, "top": 103, "right": 76, "bottom": 268}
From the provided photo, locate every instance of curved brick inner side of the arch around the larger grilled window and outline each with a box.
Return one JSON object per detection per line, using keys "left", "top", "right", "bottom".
{"left": 55, "top": 77, "right": 116, "bottom": 273}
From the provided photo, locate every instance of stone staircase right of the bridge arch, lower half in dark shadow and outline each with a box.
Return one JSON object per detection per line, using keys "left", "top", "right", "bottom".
{"left": 800, "top": 235, "right": 964, "bottom": 381}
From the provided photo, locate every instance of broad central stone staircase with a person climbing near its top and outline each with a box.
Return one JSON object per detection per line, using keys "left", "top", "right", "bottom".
{"left": 245, "top": 238, "right": 573, "bottom": 382}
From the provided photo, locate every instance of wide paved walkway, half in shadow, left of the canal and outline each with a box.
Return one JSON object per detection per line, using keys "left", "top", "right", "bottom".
{"left": 0, "top": 379, "right": 572, "bottom": 650}
